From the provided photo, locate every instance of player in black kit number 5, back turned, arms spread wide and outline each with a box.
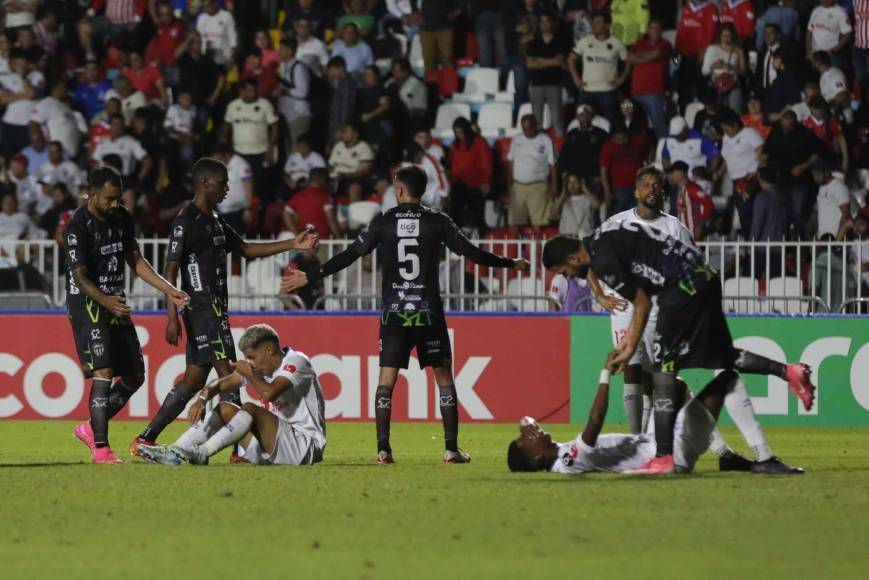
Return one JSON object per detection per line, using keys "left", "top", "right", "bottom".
{"left": 281, "top": 165, "right": 529, "bottom": 465}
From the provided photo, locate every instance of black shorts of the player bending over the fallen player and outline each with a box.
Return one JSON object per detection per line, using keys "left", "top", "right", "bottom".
{"left": 655, "top": 267, "right": 733, "bottom": 372}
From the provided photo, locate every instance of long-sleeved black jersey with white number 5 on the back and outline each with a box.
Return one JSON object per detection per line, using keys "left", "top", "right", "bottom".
{"left": 315, "top": 204, "right": 513, "bottom": 326}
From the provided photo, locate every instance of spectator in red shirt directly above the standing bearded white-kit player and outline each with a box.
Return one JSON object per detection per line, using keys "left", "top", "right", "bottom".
{"left": 599, "top": 123, "right": 651, "bottom": 214}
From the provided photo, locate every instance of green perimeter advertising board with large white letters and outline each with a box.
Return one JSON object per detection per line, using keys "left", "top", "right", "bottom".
{"left": 570, "top": 316, "right": 869, "bottom": 427}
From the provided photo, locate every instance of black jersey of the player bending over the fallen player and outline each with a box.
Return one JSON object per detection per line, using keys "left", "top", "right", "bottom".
{"left": 585, "top": 221, "right": 709, "bottom": 300}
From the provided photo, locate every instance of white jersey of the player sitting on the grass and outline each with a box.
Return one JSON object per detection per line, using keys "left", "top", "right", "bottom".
{"left": 245, "top": 348, "right": 326, "bottom": 450}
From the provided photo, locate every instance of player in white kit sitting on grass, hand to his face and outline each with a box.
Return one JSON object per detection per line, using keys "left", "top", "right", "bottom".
{"left": 139, "top": 324, "right": 326, "bottom": 465}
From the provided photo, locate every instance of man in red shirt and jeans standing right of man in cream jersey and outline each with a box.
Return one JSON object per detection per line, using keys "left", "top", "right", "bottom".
{"left": 628, "top": 18, "right": 673, "bottom": 139}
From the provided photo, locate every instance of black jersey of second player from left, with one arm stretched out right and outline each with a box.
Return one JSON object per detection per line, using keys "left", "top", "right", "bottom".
{"left": 166, "top": 202, "right": 244, "bottom": 310}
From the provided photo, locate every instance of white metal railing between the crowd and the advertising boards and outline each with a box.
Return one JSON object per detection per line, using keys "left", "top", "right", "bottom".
{"left": 0, "top": 239, "right": 869, "bottom": 314}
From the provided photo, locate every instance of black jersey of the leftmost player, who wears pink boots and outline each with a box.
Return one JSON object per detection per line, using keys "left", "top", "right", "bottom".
{"left": 64, "top": 205, "right": 138, "bottom": 304}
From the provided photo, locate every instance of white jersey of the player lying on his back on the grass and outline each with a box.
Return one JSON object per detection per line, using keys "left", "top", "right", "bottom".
{"left": 549, "top": 433, "right": 656, "bottom": 473}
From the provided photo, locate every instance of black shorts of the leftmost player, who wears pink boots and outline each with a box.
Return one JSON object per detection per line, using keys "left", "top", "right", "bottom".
{"left": 68, "top": 298, "right": 145, "bottom": 378}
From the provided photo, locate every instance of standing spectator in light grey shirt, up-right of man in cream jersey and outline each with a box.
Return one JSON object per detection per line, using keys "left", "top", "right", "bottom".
{"left": 278, "top": 38, "right": 311, "bottom": 145}
